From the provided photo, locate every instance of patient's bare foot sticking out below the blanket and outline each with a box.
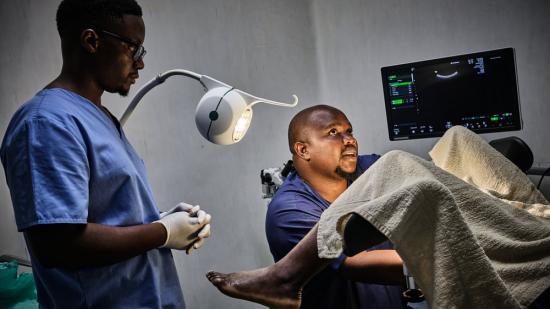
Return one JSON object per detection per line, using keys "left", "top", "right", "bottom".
{"left": 206, "top": 268, "right": 302, "bottom": 309}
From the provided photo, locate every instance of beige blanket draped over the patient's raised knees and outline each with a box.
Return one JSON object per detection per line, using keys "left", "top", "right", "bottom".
{"left": 317, "top": 127, "right": 550, "bottom": 309}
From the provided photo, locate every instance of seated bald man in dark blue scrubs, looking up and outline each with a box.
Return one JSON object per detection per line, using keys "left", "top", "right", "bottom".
{"left": 266, "top": 105, "right": 404, "bottom": 309}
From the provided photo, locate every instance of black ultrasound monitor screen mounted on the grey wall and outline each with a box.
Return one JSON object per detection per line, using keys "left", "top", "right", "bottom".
{"left": 381, "top": 48, "right": 521, "bottom": 141}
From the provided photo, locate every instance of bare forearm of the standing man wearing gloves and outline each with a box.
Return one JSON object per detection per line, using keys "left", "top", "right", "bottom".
{"left": 26, "top": 223, "right": 166, "bottom": 268}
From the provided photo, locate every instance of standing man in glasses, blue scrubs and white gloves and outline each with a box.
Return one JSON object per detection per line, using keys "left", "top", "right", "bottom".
{"left": 0, "top": 0, "right": 210, "bottom": 308}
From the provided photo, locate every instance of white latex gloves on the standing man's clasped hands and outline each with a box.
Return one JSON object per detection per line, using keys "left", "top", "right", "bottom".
{"left": 155, "top": 207, "right": 209, "bottom": 250}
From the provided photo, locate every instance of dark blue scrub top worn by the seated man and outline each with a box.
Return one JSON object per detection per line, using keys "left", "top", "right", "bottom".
{"left": 266, "top": 154, "right": 402, "bottom": 309}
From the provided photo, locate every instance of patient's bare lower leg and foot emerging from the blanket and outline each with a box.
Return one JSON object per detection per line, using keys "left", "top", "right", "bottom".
{"left": 206, "top": 226, "right": 332, "bottom": 308}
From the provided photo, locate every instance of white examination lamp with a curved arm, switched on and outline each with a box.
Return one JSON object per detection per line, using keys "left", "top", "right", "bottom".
{"left": 120, "top": 69, "right": 298, "bottom": 145}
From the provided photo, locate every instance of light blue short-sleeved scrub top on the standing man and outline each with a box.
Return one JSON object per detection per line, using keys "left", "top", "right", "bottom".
{"left": 0, "top": 88, "right": 185, "bottom": 308}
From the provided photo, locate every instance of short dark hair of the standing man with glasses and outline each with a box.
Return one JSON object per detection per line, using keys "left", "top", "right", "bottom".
{"left": 56, "top": 0, "right": 142, "bottom": 39}
